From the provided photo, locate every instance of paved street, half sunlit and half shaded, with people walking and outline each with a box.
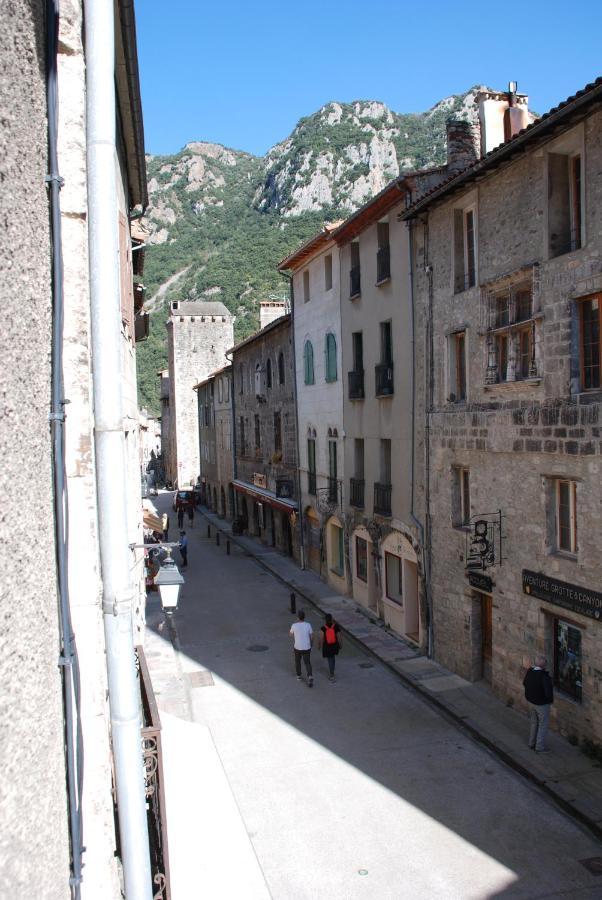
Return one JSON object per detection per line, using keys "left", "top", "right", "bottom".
{"left": 149, "top": 495, "right": 602, "bottom": 900}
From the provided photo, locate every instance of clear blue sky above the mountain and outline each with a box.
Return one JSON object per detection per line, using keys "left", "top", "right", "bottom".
{"left": 136, "top": 0, "right": 602, "bottom": 155}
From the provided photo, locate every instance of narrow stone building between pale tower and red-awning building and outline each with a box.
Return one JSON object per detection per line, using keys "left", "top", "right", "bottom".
{"left": 195, "top": 366, "right": 234, "bottom": 519}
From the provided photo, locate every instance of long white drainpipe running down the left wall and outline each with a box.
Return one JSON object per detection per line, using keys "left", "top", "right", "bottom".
{"left": 85, "top": 0, "right": 152, "bottom": 900}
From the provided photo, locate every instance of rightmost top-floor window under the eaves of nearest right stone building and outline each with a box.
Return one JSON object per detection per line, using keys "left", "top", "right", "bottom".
{"left": 548, "top": 153, "right": 582, "bottom": 258}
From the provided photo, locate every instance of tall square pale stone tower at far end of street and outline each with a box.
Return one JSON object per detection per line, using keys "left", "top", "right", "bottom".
{"left": 167, "top": 300, "right": 234, "bottom": 487}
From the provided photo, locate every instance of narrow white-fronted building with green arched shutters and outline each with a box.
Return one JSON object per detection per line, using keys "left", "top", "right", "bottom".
{"left": 279, "top": 225, "right": 346, "bottom": 590}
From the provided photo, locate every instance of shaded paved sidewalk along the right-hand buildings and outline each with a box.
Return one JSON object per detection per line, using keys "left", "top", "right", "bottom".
{"left": 197, "top": 507, "right": 602, "bottom": 838}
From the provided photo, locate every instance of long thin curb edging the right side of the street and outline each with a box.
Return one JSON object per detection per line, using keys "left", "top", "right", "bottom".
{"left": 200, "top": 509, "right": 602, "bottom": 841}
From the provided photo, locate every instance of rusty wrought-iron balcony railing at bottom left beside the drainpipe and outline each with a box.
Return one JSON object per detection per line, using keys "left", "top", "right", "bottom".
{"left": 134, "top": 646, "right": 171, "bottom": 900}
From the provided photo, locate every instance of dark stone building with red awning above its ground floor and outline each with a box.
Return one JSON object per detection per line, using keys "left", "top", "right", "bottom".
{"left": 229, "top": 314, "right": 302, "bottom": 560}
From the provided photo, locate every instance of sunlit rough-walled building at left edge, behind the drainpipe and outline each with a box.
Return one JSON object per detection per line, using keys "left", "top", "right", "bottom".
{"left": 0, "top": 0, "right": 155, "bottom": 900}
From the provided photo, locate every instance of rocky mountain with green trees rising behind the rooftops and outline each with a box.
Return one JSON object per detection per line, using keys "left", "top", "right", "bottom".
{"left": 138, "top": 88, "right": 478, "bottom": 411}
